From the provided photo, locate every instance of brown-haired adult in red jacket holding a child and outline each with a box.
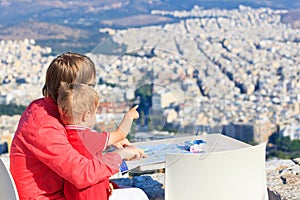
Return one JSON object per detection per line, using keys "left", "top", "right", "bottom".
{"left": 10, "top": 53, "right": 142, "bottom": 199}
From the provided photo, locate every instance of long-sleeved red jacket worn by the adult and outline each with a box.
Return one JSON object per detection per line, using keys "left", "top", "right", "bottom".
{"left": 10, "top": 98, "right": 121, "bottom": 200}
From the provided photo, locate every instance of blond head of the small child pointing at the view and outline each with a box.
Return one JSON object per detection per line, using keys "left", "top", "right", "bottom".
{"left": 57, "top": 82, "right": 99, "bottom": 125}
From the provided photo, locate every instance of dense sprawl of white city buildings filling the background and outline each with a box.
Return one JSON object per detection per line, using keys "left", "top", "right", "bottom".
{"left": 0, "top": 5, "right": 300, "bottom": 199}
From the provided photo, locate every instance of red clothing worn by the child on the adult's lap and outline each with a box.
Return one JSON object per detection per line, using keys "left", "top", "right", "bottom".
{"left": 64, "top": 125, "right": 110, "bottom": 200}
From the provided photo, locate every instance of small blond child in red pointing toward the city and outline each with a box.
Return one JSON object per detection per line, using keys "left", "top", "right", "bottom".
{"left": 57, "top": 83, "right": 148, "bottom": 200}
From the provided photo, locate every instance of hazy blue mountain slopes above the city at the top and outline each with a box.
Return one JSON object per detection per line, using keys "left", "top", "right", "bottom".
{"left": 0, "top": 0, "right": 300, "bottom": 54}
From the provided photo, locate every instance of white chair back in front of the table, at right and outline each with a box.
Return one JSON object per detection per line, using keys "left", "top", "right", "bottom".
{"left": 165, "top": 144, "right": 268, "bottom": 200}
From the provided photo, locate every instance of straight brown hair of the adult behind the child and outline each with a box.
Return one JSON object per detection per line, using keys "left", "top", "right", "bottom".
{"left": 43, "top": 53, "right": 96, "bottom": 103}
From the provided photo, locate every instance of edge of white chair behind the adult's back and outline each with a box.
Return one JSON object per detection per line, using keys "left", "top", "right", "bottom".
{"left": 0, "top": 158, "right": 19, "bottom": 200}
